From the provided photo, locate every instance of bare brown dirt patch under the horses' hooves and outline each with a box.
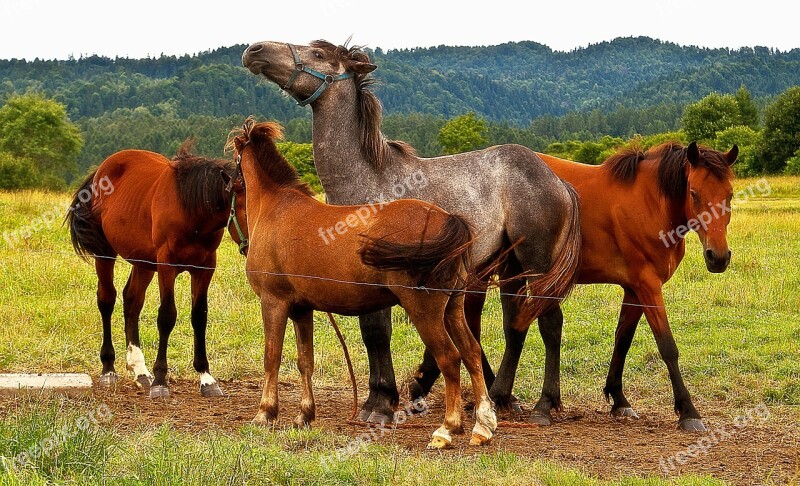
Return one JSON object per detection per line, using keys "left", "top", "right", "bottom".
{"left": 7, "top": 379, "right": 800, "bottom": 484}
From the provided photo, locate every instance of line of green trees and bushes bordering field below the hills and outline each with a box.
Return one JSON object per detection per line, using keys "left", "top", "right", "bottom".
{"left": 0, "top": 82, "right": 800, "bottom": 191}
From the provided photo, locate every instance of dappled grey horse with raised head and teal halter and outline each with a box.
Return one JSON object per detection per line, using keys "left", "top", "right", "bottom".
{"left": 242, "top": 41, "right": 581, "bottom": 422}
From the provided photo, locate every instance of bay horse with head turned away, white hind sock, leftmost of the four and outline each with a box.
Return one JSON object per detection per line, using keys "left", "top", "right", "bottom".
{"left": 67, "top": 142, "right": 246, "bottom": 398}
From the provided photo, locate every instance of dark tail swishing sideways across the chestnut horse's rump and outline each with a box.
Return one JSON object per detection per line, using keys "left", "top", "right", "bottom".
{"left": 360, "top": 214, "right": 472, "bottom": 287}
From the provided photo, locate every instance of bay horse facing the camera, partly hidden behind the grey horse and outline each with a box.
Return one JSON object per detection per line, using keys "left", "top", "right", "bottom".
{"left": 412, "top": 143, "right": 739, "bottom": 431}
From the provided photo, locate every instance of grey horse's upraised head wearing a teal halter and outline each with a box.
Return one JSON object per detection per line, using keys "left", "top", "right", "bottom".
{"left": 242, "top": 40, "right": 377, "bottom": 106}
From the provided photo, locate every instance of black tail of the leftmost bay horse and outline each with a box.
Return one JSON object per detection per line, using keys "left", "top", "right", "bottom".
{"left": 65, "top": 170, "right": 115, "bottom": 260}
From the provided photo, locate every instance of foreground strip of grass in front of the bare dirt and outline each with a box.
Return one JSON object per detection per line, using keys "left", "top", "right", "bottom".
{"left": 0, "top": 401, "right": 723, "bottom": 485}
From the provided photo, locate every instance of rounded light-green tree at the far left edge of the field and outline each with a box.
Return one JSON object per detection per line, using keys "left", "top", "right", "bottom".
{"left": 0, "top": 93, "right": 83, "bottom": 187}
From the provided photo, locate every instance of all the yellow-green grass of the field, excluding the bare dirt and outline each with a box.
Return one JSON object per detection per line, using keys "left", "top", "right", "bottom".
{"left": 0, "top": 177, "right": 800, "bottom": 484}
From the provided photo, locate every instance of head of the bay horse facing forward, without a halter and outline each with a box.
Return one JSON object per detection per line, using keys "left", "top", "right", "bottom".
{"left": 684, "top": 142, "right": 739, "bottom": 273}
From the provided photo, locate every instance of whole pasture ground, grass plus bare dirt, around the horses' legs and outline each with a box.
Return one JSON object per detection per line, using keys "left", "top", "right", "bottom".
{"left": 0, "top": 177, "right": 800, "bottom": 484}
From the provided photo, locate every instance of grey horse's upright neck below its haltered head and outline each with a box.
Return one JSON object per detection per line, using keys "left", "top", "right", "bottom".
{"left": 311, "top": 81, "right": 379, "bottom": 204}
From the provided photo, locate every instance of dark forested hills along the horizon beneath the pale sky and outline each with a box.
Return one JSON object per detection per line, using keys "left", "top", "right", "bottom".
{"left": 0, "top": 37, "right": 800, "bottom": 125}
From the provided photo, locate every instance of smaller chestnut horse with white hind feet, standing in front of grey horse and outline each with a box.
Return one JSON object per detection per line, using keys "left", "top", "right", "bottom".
{"left": 232, "top": 119, "right": 497, "bottom": 448}
